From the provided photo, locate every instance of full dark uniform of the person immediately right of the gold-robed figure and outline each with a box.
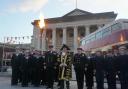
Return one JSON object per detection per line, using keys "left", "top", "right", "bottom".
{"left": 73, "top": 53, "right": 87, "bottom": 89}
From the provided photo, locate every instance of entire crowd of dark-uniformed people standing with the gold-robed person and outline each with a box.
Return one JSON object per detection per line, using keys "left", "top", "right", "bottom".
{"left": 11, "top": 44, "right": 128, "bottom": 89}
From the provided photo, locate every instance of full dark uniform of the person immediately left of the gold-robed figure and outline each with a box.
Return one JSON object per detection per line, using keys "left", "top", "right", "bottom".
{"left": 45, "top": 51, "right": 57, "bottom": 88}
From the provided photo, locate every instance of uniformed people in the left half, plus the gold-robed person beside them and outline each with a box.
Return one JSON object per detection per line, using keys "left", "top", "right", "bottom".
{"left": 11, "top": 45, "right": 72, "bottom": 88}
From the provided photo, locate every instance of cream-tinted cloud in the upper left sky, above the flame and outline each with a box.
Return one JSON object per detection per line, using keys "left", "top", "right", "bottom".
{"left": 9, "top": 0, "right": 48, "bottom": 12}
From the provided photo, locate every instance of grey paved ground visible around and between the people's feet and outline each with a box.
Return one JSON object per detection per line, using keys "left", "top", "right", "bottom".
{"left": 0, "top": 70, "right": 120, "bottom": 89}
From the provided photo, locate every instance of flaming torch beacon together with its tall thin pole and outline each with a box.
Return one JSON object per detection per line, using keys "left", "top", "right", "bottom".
{"left": 38, "top": 14, "right": 45, "bottom": 50}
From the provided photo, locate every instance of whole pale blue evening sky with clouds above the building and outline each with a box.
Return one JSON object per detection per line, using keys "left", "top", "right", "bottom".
{"left": 0, "top": 0, "right": 128, "bottom": 43}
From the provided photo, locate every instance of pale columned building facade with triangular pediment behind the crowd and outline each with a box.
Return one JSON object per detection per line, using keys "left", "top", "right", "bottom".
{"left": 32, "top": 9, "right": 117, "bottom": 52}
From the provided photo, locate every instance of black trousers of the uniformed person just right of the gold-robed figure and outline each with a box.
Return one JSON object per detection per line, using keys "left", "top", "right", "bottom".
{"left": 75, "top": 68, "right": 85, "bottom": 89}
